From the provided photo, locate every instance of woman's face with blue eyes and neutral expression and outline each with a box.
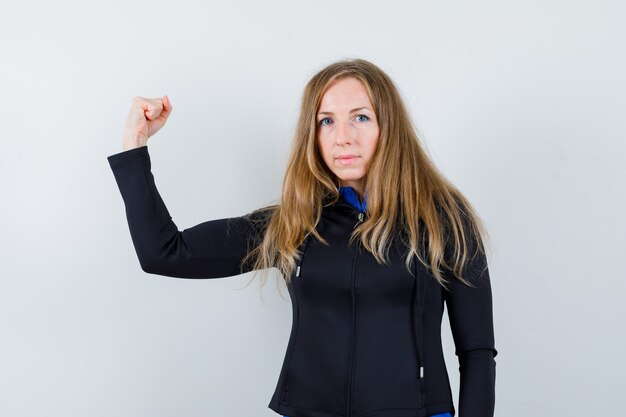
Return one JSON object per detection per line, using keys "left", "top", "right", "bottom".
{"left": 317, "top": 77, "right": 379, "bottom": 196}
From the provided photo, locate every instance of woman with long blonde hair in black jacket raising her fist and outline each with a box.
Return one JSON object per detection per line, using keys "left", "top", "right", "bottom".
{"left": 108, "top": 59, "right": 497, "bottom": 417}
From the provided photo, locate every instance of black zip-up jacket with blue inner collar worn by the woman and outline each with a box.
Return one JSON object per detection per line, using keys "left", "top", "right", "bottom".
{"left": 108, "top": 146, "right": 497, "bottom": 417}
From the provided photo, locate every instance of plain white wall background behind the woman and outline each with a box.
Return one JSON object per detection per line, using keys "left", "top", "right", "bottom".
{"left": 0, "top": 0, "right": 626, "bottom": 417}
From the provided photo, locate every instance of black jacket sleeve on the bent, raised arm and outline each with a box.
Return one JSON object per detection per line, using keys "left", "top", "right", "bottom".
{"left": 107, "top": 146, "right": 259, "bottom": 278}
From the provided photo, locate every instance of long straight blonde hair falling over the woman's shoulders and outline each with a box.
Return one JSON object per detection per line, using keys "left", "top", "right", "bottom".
{"left": 242, "top": 59, "right": 487, "bottom": 288}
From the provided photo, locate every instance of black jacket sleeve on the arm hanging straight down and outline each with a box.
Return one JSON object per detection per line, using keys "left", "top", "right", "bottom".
{"left": 444, "top": 221, "right": 498, "bottom": 417}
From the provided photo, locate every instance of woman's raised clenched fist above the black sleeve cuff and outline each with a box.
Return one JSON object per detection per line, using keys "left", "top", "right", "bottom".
{"left": 124, "top": 96, "right": 172, "bottom": 150}
